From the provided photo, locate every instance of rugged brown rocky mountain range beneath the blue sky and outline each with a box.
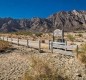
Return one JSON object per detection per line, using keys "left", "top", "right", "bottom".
{"left": 0, "top": 10, "right": 86, "bottom": 32}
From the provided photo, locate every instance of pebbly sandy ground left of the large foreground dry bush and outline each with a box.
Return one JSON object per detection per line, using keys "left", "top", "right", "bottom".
{"left": 0, "top": 45, "right": 51, "bottom": 80}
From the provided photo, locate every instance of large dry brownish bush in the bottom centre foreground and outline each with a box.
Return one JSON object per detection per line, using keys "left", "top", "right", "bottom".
{"left": 23, "top": 56, "right": 69, "bottom": 80}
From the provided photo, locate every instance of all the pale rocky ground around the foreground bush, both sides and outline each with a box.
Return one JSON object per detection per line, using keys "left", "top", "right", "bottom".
{"left": 0, "top": 45, "right": 86, "bottom": 80}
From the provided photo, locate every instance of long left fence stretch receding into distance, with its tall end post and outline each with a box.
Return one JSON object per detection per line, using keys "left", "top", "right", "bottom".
{"left": 0, "top": 36, "right": 41, "bottom": 52}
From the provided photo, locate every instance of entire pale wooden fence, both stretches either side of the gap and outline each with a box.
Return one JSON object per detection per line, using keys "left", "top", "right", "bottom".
{"left": 0, "top": 36, "right": 78, "bottom": 53}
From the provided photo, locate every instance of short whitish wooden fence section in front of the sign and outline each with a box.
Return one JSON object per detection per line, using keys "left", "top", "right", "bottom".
{"left": 49, "top": 41, "right": 78, "bottom": 56}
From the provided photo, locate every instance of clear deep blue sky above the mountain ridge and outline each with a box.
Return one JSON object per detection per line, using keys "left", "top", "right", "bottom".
{"left": 0, "top": 0, "right": 86, "bottom": 18}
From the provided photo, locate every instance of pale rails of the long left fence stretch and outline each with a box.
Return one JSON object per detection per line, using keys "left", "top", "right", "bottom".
{"left": 0, "top": 37, "right": 41, "bottom": 49}
